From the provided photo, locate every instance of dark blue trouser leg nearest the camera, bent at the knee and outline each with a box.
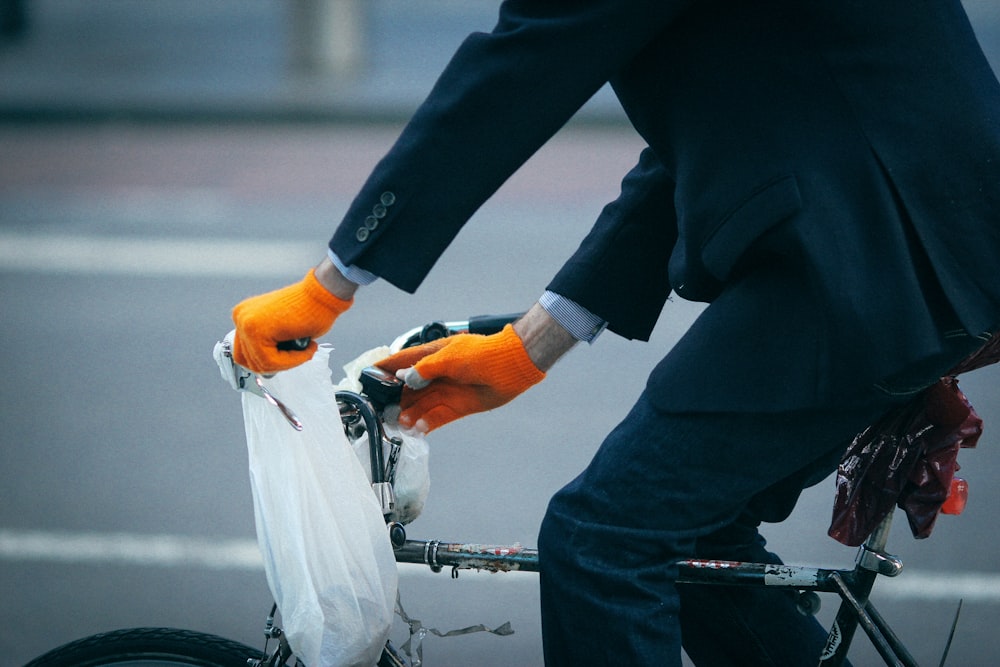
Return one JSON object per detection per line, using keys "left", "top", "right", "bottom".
{"left": 539, "top": 397, "right": 886, "bottom": 666}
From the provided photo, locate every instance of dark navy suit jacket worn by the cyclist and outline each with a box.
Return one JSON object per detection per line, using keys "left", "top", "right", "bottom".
{"left": 331, "top": 0, "right": 1000, "bottom": 409}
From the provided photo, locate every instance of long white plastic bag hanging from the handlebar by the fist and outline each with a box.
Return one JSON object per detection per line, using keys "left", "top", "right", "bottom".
{"left": 243, "top": 346, "right": 398, "bottom": 667}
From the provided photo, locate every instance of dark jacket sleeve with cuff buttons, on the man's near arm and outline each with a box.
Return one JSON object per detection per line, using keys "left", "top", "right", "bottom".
{"left": 330, "top": 0, "right": 692, "bottom": 291}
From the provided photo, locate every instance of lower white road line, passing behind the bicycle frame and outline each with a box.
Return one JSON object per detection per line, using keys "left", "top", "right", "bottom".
{"left": 0, "top": 529, "right": 1000, "bottom": 604}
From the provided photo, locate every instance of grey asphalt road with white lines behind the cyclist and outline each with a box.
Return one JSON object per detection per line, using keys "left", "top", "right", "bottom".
{"left": 0, "top": 124, "right": 1000, "bottom": 667}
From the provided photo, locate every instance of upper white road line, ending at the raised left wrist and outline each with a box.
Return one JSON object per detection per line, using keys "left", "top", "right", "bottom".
{"left": 0, "top": 233, "right": 325, "bottom": 277}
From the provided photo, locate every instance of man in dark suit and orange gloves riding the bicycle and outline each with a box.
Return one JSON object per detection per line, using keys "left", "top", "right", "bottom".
{"left": 234, "top": 0, "right": 1000, "bottom": 665}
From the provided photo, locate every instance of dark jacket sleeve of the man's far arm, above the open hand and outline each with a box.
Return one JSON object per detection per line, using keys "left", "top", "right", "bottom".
{"left": 548, "top": 148, "right": 677, "bottom": 340}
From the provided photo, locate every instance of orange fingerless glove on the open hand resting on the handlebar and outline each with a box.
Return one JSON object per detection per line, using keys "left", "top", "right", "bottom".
{"left": 378, "top": 324, "right": 545, "bottom": 433}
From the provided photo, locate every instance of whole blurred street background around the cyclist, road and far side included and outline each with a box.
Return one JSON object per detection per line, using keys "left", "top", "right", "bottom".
{"left": 0, "top": 0, "right": 1000, "bottom": 666}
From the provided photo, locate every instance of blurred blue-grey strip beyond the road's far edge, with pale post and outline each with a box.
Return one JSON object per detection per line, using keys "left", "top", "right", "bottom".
{"left": 0, "top": 0, "right": 616, "bottom": 121}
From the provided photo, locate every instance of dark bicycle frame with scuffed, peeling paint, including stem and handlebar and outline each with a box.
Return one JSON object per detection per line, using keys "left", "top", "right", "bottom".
{"left": 250, "top": 316, "right": 944, "bottom": 667}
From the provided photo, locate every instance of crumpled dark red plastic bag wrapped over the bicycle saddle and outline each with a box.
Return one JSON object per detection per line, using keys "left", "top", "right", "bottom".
{"left": 828, "top": 335, "right": 1000, "bottom": 546}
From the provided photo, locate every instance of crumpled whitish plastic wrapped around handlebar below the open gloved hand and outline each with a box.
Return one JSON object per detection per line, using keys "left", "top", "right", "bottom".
{"left": 337, "top": 346, "right": 431, "bottom": 525}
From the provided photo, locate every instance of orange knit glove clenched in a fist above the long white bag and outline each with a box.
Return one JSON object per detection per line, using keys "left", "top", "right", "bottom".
{"left": 233, "top": 270, "right": 354, "bottom": 373}
